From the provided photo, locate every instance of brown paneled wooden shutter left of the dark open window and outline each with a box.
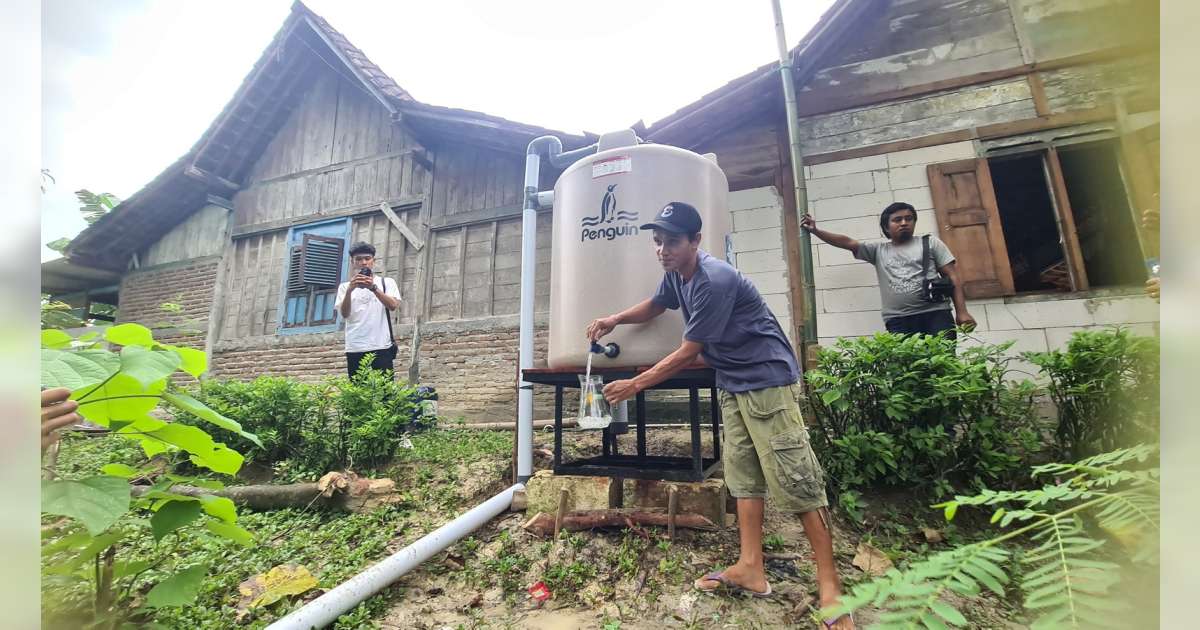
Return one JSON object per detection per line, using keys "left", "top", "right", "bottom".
{"left": 928, "top": 160, "right": 1015, "bottom": 298}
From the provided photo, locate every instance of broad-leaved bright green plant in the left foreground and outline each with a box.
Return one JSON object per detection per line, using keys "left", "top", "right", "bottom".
{"left": 41, "top": 324, "right": 258, "bottom": 628}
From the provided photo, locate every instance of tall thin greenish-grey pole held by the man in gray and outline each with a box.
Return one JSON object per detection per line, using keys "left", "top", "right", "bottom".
{"left": 770, "top": 0, "right": 817, "bottom": 343}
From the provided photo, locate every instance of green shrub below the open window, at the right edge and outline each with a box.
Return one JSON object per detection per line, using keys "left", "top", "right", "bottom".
{"left": 1024, "top": 329, "right": 1159, "bottom": 460}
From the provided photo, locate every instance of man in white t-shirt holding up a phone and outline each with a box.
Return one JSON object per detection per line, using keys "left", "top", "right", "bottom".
{"left": 336, "top": 242, "right": 400, "bottom": 378}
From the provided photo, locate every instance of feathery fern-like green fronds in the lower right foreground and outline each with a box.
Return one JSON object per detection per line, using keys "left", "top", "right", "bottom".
{"left": 822, "top": 445, "right": 1159, "bottom": 629}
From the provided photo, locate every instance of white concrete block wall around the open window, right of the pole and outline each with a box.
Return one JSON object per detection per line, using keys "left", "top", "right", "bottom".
{"left": 801, "top": 142, "right": 1158, "bottom": 362}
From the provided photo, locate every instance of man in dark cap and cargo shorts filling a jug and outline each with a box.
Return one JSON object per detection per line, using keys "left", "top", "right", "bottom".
{"left": 587, "top": 202, "right": 853, "bottom": 629}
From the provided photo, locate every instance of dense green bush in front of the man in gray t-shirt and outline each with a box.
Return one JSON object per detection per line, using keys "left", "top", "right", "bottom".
{"left": 805, "top": 332, "right": 1036, "bottom": 501}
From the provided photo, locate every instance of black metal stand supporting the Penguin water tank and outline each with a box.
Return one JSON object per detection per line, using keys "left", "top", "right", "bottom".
{"left": 523, "top": 368, "right": 721, "bottom": 481}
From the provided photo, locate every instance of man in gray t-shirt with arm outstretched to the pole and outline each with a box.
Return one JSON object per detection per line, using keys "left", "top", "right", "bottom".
{"left": 800, "top": 202, "right": 976, "bottom": 338}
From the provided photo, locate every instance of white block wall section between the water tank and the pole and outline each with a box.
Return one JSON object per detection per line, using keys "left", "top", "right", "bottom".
{"left": 724, "top": 186, "right": 792, "bottom": 340}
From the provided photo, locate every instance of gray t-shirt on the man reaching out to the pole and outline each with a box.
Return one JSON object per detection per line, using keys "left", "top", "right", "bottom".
{"left": 854, "top": 235, "right": 954, "bottom": 319}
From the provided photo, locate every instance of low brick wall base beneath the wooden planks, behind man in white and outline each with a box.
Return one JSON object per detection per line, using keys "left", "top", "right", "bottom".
{"left": 211, "top": 316, "right": 553, "bottom": 421}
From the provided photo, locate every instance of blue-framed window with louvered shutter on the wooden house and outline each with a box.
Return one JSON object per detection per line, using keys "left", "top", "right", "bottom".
{"left": 276, "top": 218, "right": 350, "bottom": 335}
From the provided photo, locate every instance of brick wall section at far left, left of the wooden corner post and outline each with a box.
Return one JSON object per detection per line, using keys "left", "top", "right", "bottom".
{"left": 118, "top": 257, "right": 217, "bottom": 348}
